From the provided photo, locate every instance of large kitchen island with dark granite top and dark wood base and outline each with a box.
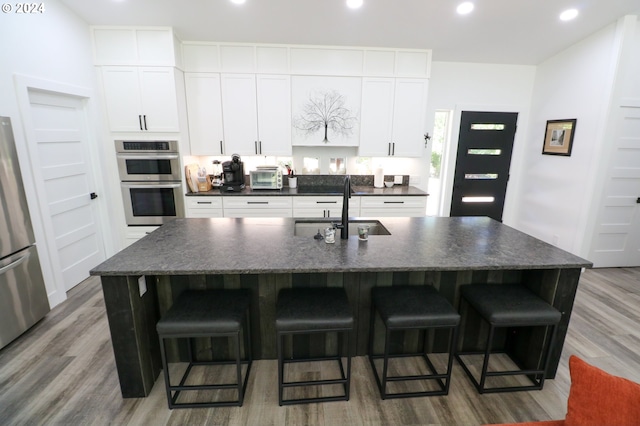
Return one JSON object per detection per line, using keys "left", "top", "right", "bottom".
{"left": 91, "top": 217, "right": 591, "bottom": 397}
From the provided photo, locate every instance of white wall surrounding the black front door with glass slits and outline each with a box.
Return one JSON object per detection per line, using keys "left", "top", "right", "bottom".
{"left": 424, "top": 62, "right": 536, "bottom": 224}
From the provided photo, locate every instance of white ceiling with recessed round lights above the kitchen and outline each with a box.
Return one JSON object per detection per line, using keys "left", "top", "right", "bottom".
{"left": 60, "top": 0, "right": 640, "bottom": 65}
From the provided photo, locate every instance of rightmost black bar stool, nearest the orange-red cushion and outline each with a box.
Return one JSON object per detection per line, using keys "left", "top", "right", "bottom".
{"left": 456, "top": 284, "right": 562, "bottom": 393}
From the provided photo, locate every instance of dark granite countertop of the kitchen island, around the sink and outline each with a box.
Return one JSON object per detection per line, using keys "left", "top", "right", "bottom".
{"left": 91, "top": 217, "right": 592, "bottom": 275}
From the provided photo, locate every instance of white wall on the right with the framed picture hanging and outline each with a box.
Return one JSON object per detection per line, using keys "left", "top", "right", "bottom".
{"left": 515, "top": 23, "right": 617, "bottom": 256}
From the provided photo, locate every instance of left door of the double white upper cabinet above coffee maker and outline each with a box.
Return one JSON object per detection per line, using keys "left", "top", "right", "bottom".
{"left": 221, "top": 74, "right": 258, "bottom": 155}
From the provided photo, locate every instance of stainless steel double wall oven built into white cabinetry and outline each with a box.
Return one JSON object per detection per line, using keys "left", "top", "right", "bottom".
{"left": 116, "top": 141, "right": 184, "bottom": 226}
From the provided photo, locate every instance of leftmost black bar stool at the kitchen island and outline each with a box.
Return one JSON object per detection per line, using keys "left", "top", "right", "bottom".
{"left": 156, "top": 289, "right": 252, "bottom": 409}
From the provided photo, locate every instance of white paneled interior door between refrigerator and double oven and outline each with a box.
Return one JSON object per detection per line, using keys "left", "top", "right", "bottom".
{"left": 29, "top": 89, "right": 105, "bottom": 291}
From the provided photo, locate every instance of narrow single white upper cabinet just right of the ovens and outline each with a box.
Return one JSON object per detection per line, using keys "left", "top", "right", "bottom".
{"left": 184, "top": 73, "right": 225, "bottom": 155}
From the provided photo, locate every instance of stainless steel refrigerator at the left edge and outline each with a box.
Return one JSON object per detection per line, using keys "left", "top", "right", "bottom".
{"left": 0, "top": 117, "right": 50, "bottom": 349}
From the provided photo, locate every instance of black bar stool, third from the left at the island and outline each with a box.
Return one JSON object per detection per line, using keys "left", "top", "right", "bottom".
{"left": 369, "top": 286, "right": 460, "bottom": 399}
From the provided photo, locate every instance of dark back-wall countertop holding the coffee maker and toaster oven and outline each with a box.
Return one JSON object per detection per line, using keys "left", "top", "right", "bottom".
{"left": 186, "top": 185, "right": 429, "bottom": 197}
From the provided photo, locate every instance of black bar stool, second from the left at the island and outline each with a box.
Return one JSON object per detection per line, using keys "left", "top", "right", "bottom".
{"left": 276, "top": 287, "right": 354, "bottom": 406}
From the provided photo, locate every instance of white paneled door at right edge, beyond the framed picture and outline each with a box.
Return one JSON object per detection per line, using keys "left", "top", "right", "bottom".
{"left": 589, "top": 101, "right": 640, "bottom": 267}
